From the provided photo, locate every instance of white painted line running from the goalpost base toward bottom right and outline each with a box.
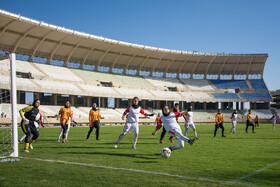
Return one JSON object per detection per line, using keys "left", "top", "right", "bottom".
{"left": 20, "top": 157, "right": 254, "bottom": 186}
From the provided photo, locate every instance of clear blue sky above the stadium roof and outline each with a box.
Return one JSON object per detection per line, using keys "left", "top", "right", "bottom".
{"left": 0, "top": 0, "right": 280, "bottom": 90}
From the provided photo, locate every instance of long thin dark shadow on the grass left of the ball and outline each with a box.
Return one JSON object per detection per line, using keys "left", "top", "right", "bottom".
{"left": 62, "top": 152, "right": 158, "bottom": 160}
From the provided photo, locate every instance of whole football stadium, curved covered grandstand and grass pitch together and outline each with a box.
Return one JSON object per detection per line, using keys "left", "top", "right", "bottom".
{"left": 0, "top": 3, "right": 280, "bottom": 186}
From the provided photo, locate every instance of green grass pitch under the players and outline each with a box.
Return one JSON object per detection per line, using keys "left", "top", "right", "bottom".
{"left": 0, "top": 124, "right": 280, "bottom": 186}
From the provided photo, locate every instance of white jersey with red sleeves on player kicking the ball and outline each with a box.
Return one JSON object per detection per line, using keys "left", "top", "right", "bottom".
{"left": 160, "top": 112, "right": 182, "bottom": 132}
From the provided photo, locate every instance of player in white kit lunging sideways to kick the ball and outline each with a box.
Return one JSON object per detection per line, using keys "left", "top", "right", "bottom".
{"left": 160, "top": 105, "right": 195, "bottom": 151}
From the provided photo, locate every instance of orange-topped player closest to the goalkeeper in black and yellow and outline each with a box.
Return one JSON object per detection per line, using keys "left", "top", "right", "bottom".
{"left": 57, "top": 101, "right": 73, "bottom": 143}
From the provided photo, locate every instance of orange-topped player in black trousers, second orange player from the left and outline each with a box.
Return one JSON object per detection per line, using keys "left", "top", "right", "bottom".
{"left": 86, "top": 103, "right": 104, "bottom": 141}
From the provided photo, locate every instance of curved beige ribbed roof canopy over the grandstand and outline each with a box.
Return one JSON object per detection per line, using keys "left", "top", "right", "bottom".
{"left": 0, "top": 10, "right": 268, "bottom": 78}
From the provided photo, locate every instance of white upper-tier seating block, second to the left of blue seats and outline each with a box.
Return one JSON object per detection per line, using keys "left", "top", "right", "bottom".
{"left": 145, "top": 77, "right": 186, "bottom": 90}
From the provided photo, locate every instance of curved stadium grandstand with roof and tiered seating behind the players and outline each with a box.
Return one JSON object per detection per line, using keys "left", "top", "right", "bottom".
{"left": 0, "top": 10, "right": 272, "bottom": 124}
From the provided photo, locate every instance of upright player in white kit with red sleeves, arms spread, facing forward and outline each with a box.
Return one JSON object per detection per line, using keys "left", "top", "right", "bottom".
{"left": 114, "top": 97, "right": 154, "bottom": 149}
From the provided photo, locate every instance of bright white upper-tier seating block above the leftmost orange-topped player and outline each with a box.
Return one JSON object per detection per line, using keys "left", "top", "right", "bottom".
{"left": 34, "top": 63, "right": 83, "bottom": 82}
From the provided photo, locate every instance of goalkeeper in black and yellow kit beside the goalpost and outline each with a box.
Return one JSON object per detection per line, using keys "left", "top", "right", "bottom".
{"left": 19, "top": 99, "right": 40, "bottom": 153}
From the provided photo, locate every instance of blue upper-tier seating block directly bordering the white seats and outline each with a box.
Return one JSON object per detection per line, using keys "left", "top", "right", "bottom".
{"left": 210, "top": 80, "right": 249, "bottom": 89}
